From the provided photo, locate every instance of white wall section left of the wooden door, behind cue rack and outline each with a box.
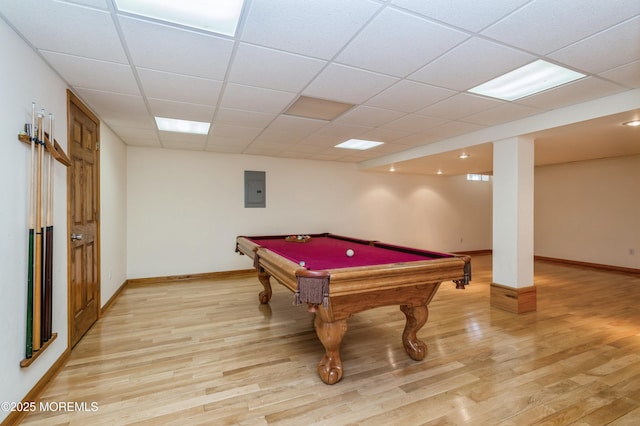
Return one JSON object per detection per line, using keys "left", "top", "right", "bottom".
{"left": 0, "top": 20, "right": 67, "bottom": 421}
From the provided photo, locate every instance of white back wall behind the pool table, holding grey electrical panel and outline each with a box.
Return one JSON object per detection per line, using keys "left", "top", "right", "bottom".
{"left": 127, "top": 147, "right": 491, "bottom": 278}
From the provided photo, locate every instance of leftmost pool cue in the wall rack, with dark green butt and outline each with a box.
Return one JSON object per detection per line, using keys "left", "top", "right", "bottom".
{"left": 25, "top": 102, "right": 36, "bottom": 358}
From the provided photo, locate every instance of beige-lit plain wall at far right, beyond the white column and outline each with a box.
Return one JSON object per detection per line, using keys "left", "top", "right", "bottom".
{"left": 535, "top": 155, "right": 640, "bottom": 269}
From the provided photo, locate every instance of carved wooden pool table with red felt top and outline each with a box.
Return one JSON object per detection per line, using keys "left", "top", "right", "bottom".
{"left": 236, "top": 233, "right": 471, "bottom": 385}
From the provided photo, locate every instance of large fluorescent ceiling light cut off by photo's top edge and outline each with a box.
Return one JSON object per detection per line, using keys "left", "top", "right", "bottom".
{"left": 116, "top": 0, "right": 244, "bottom": 37}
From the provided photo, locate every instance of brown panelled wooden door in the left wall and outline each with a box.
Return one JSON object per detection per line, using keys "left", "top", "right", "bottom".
{"left": 67, "top": 92, "right": 100, "bottom": 347}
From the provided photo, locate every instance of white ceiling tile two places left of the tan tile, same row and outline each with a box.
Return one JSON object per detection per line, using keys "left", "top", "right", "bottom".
{"left": 138, "top": 68, "right": 222, "bottom": 106}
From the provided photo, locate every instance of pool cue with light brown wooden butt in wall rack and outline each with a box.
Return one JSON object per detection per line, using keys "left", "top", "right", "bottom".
{"left": 33, "top": 114, "right": 44, "bottom": 351}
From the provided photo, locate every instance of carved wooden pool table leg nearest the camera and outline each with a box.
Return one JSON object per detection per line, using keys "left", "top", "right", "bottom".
{"left": 315, "top": 312, "right": 347, "bottom": 385}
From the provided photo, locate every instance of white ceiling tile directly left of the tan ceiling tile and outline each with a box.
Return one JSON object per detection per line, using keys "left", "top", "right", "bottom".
{"left": 220, "top": 83, "right": 296, "bottom": 113}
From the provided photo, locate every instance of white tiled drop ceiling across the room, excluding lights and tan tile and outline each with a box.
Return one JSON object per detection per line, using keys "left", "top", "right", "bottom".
{"left": 0, "top": 0, "right": 640, "bottom": 174}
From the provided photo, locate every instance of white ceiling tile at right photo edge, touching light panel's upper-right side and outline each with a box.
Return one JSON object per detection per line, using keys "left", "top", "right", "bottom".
{"left": 549, "top": 16, "right": 640, "bottom": 74}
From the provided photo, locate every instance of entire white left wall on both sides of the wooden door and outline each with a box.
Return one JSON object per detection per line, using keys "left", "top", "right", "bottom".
{"left": 0, "top": 20, "right": 127, "bottom": 422}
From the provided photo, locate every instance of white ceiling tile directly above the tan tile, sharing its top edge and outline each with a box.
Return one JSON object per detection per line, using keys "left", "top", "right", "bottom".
{"left": 303, "top": 64, "right": 398, "bottom": 104}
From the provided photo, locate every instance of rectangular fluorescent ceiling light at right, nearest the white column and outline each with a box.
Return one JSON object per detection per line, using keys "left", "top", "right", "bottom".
{"left": 468, "top": 60, "right": 585, "bottom": 101}
